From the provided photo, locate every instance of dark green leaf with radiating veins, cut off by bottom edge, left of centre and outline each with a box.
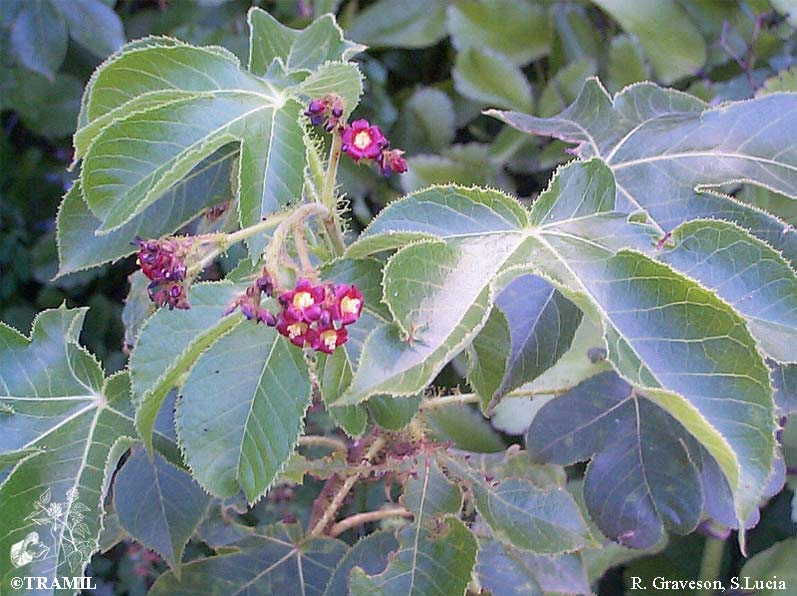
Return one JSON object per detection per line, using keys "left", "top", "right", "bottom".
{"left": 149, "top": 524, "right": 348, "bottom": 596}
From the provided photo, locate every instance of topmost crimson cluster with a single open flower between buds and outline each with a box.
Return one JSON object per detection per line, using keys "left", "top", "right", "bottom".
{"left": 305, "top": 95, "right": 407, "bottom": 176}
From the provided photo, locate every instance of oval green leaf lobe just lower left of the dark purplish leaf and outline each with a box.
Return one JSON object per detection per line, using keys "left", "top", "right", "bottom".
{"left": 445, "top": 458, "right": 591, "bottom": 554}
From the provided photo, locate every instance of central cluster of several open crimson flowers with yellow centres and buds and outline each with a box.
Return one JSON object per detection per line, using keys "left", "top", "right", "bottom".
{"left": 227, "top": 269, "right": 363, "bottom": 354}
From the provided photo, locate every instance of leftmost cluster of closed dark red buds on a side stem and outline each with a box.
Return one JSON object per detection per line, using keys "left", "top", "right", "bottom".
{"left": 136, "top": 238, "right": 192, "bottom": 310}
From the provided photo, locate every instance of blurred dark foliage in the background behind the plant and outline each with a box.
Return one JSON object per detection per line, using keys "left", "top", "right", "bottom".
{"left": 0, "top": 0, "right": 797, "bottom": 594}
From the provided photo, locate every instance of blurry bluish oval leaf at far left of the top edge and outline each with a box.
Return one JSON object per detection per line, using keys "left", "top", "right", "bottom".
{"left": 11, "top": 0, "right": 69, "bottom": 81}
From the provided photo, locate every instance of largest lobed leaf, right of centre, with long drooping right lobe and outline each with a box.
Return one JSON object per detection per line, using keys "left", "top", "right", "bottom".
{"left": 339, "top": 157, "right": 782, "bottom": 536}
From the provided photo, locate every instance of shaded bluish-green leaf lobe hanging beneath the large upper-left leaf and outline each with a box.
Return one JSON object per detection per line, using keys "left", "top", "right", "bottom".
{"left": 56, "top": 145, "right": 235, "bottom": 276}
